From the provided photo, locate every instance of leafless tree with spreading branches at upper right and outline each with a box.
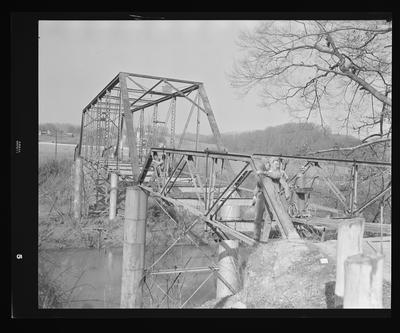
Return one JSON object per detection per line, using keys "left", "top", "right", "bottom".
{"left": 231, "top": 21, "right": 392, "bottom": 140}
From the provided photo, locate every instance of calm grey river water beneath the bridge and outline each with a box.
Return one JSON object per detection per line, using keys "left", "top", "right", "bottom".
{"left": 39, "top": 245, "right": 250, "bottom": 308}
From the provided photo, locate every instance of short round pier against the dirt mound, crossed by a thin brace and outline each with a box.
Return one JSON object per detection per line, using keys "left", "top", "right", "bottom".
{"left": 216, "top": 240, "right": 240, "bottom": 298}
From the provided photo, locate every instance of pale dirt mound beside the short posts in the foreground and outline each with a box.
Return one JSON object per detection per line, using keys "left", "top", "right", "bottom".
{"left": 202, "top": 240, "right": 391, "bottom": 309}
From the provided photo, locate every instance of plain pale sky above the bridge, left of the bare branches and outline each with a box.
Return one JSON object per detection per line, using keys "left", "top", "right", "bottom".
{"left": 39, "top": 21, "right": 328, "bottom": 132}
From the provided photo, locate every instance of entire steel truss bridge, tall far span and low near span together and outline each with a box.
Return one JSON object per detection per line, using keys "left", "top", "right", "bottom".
{"left": 75, "top": 73, "right": 391, "bottom": 308}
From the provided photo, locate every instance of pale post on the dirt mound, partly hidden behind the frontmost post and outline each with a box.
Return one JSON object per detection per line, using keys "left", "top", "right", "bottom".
{"left": 335, "top": 217, "right": 365, "bottom": 297}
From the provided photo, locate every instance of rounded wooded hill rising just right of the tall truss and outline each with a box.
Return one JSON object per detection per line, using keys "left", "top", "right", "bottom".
{"left": 186, "top": 123, "right": 361, "bottom": 155}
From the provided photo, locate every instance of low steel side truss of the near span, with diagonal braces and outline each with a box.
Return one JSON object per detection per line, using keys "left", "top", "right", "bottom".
{"left": 139, "top": 148, "right": 391, "bottom": 239}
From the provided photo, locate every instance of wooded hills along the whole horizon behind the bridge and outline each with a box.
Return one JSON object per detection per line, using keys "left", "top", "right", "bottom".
{"left": 39, "top": 123, "right": 391, "bottom": 160}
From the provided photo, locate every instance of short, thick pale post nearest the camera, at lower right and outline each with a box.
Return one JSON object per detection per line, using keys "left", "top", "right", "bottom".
{"left": 343, "top": 254, "right": 383, "bottom": 309}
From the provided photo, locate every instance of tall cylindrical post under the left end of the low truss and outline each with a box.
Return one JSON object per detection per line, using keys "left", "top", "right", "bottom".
{"left": 121, "top": 186, "right": 148, "bottom": 308}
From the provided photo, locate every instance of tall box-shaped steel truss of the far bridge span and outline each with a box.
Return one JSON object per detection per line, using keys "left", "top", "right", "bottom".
{"left": 75, "top": 72, "right": 236, "bottom": 211}
